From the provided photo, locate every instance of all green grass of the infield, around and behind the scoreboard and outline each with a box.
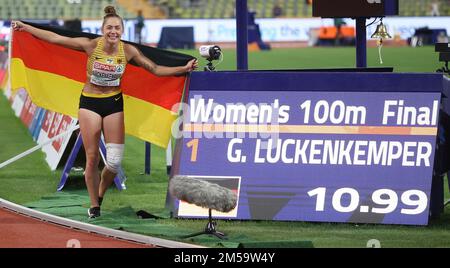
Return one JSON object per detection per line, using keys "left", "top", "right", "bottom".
{"left": 0, "top": 47, "right": 450, "bottom": 247}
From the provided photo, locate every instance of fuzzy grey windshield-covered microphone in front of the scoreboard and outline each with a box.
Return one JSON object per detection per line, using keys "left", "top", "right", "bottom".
{"left": 169, "top": 176, "right": 237, "bottom": 212}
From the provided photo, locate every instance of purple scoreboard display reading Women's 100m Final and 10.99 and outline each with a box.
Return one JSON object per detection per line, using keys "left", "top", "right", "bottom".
{"left": 171, "top": 72, "right": 442, "bottom": 225}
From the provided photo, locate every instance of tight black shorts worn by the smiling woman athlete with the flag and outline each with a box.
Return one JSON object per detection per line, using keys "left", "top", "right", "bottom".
{"left": 79, "top": 93, "right": 123, "bottom": 118}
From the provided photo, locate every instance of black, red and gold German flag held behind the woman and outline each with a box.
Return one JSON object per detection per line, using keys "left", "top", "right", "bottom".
{"left": 11, "top": 22, "right": 193, "bottom": 148}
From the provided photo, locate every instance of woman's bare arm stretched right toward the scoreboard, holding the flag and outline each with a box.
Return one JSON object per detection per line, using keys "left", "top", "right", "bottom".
{"left": 125, "top": 44, "right": 197, "bottom": 76}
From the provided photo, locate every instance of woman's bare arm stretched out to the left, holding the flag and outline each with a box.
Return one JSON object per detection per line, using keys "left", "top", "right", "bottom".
{"left": 12, "top": 21, "right": 93, "bottom": 52}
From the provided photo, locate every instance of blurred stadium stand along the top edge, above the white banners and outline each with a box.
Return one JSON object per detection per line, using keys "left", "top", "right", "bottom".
{"left": 0, "top": 0, "right": 450, "bottom": 20}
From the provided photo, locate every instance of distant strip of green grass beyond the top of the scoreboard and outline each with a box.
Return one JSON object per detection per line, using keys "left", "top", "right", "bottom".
{"left": 192, "top": 46, "right": 443, "bottom": 73}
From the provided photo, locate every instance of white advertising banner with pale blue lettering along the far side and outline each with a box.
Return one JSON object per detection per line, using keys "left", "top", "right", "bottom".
{"left": 82, "top": 16, "right": 450, "bottom": 44}
